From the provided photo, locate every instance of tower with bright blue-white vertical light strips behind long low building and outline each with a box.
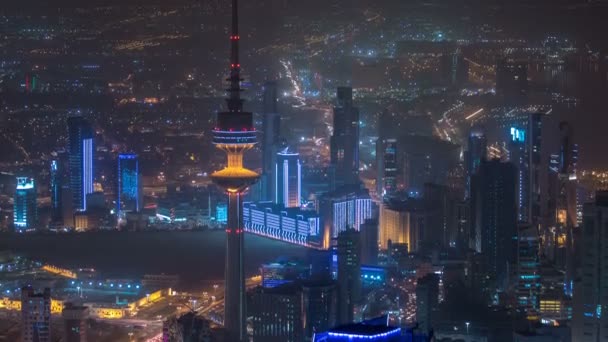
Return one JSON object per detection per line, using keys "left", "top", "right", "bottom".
{"left": 274, "top": 148, "right": 302, "bottom": 208}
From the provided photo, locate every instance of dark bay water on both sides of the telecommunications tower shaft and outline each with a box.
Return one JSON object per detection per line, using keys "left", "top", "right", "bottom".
{"left": 0, "top": 231, "right": 306, "bottom": 286}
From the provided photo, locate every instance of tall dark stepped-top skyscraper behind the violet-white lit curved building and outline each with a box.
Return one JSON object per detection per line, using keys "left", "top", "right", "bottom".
{"left": 330, "top": 87, "right": 359, "bottom": 187}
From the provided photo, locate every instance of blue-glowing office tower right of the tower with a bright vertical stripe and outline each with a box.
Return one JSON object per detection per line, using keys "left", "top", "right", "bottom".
{"left": 116, "top": 153, "right": 142, "bottom": 215}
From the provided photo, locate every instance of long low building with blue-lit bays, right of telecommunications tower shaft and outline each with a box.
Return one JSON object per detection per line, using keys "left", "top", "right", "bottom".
{"left": 243, "top": 202, "right": 327, "bottom": 248}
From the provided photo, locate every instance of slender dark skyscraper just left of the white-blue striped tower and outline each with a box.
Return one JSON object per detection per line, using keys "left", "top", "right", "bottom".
{"left": 260, "top": 81, "right": 281, "bottom": 201}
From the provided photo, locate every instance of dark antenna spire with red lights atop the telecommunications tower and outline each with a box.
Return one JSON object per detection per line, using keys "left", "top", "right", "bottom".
{"left": 226, "top": 0, "right": 243, "bottom": 112}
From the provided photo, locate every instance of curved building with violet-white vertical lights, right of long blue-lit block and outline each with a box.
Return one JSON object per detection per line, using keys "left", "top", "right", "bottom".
{"left": 320, "top": 187, "right": 373, "bottom": 238}
